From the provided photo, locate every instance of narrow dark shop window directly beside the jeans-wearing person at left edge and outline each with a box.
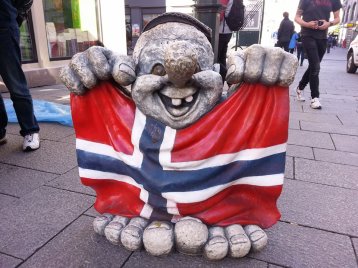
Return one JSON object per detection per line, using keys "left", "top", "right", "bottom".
{"left": 20, "top": 12, "right": 37, "bottom": 63}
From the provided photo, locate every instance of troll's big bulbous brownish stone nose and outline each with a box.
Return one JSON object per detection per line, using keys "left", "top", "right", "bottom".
{"left": 164, "top": 41, "right": 198, "bottom": 87}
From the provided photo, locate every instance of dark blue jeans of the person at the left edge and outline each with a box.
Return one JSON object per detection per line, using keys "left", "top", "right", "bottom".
{"left": 0, "top": 26, "right": 40, "bottom": 137}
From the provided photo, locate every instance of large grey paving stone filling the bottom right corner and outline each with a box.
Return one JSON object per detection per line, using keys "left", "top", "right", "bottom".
{"left": 250, "top": 222, "right": 356, "bottom": 268}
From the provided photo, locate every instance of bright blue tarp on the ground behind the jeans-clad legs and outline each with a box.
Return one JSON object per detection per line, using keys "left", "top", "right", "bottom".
{"left": 4, "top": 99, "right": 73, "bottom": 127}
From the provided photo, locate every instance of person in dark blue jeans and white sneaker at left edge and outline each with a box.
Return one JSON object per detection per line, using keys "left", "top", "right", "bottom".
{"left": 0, "top": 0, "right": 40, "bottom": 151}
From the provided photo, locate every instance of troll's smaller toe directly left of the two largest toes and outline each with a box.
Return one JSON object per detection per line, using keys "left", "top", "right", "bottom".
{"left": 121, "top": 217, "right": 148, "bottom": 251}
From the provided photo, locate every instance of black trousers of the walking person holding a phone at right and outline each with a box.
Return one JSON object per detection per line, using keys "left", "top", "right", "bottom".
{"left": 298, "top": 36, "right": 327, "bottom": 99}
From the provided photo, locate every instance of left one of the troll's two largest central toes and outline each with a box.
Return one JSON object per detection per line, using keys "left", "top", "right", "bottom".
{"left": 143, "top": 221, "right": 174, "bottom": 256}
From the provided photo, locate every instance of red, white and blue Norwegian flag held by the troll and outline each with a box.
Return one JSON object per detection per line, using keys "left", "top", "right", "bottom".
{"left": 71, "top": 82, "right": 289, "bottom": 228}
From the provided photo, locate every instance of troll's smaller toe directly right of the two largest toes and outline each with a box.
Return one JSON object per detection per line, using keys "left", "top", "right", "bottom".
{"left": 204, "top": 227, "right": 229, "bottom": 260}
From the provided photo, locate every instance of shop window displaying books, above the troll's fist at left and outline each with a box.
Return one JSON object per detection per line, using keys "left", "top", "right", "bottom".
{"left": 43, "top": 0, "right": 100, "bottom": 60}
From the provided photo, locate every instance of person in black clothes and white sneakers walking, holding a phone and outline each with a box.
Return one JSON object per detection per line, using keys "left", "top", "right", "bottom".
{"left": 295, "top": 0, "right": 342, "bottom": 109}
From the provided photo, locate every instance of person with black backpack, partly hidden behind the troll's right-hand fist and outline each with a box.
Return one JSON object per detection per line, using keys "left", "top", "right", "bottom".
{"left": 218, "top": 0, "right": 233, "bottom": 68}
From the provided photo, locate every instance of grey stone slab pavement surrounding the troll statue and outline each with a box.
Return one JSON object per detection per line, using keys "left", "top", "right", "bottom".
{"left": 0, "top": 48, "right": 358, "bottom": 268}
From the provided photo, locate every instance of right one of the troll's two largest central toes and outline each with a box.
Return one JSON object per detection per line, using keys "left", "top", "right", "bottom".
{"left": 174, "top": 217, "right": 209, "bottom": 255}
